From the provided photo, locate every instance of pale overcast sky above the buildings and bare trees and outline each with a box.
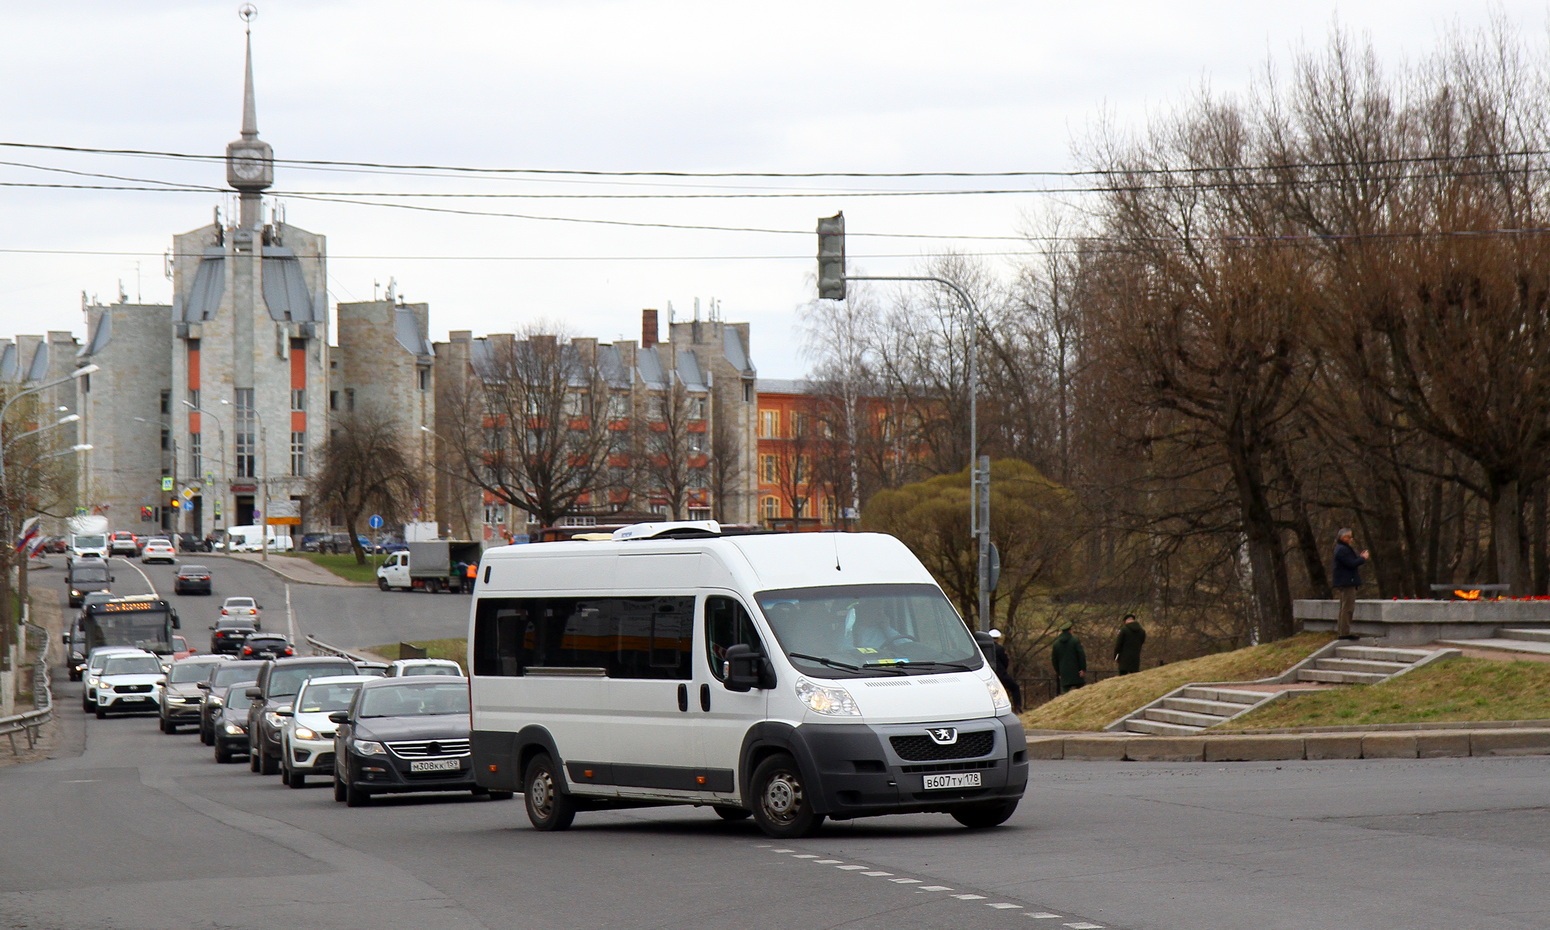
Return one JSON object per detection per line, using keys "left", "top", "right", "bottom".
{"left": 0, "top": 0, "right": 1545, "bottom": 378}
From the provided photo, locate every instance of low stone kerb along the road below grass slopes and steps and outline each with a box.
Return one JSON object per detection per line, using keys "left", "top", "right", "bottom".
{"left": 1028, "top": 721, "right": 1550, "bottom": 763}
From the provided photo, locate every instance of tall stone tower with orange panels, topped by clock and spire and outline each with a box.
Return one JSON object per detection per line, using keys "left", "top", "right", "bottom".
{"left": 166, "top": 18, "right": 329, "bottom": 533}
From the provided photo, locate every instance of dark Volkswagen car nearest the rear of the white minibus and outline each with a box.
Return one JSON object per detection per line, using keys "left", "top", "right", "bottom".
{"left": 329, "top": 676, "right": 512, "bottom": 808}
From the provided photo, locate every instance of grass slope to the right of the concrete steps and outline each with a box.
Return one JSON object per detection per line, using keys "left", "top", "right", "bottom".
{"left": 1217, "top": 657, "right": 1550, "bottom": 732}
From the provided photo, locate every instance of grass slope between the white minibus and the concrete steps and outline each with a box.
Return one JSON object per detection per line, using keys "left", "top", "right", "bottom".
{"left": 1023, "top": 632, "right": 1331, "bottom": 732}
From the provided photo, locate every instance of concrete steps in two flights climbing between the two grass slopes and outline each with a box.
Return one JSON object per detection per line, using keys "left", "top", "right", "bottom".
{"left": 1105, "top": 639, "right": 1457, "bottom": 736}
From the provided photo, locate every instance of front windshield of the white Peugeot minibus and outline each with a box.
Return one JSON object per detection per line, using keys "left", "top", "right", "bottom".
{"left": 758, "top": 584, "right": 984, "bottom": 677}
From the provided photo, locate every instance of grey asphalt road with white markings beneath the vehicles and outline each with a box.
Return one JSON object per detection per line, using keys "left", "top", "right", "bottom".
{"left": 9, "top": 560, "right": 1550, "bottom": 930}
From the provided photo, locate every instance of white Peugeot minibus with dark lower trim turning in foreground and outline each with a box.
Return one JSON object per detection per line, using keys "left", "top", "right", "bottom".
{"left": 468, "top": 522, "right": 1028, "bottom": 839}
